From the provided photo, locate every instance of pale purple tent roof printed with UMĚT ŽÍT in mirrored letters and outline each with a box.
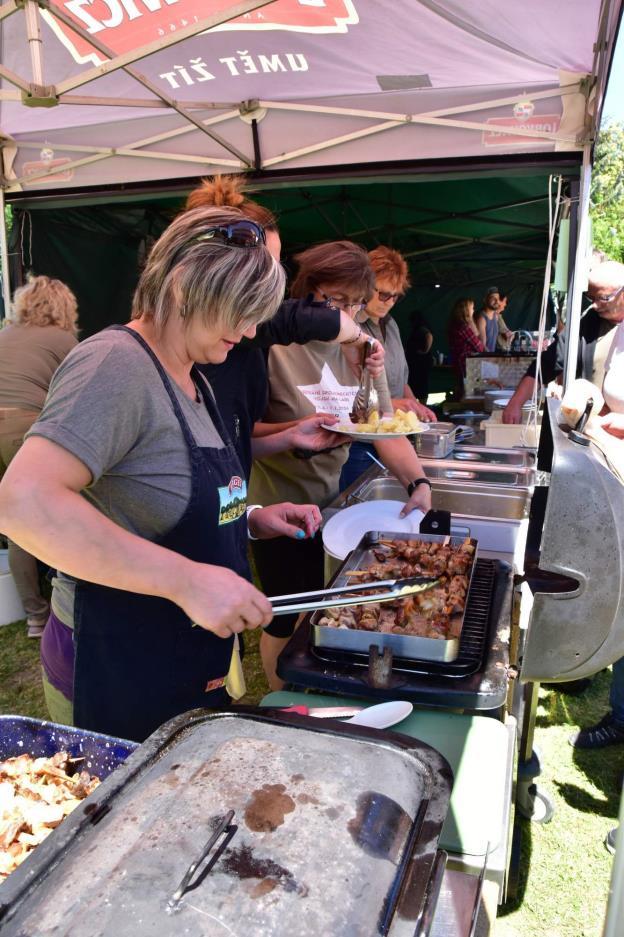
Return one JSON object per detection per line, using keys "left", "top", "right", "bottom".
{"left": 0, "top": 0, "right": 622, "bottom": 193}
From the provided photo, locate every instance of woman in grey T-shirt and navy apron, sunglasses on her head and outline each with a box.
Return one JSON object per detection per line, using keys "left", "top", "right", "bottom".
{"left": 0, "top": 209, "right": 320, "bottom": 740}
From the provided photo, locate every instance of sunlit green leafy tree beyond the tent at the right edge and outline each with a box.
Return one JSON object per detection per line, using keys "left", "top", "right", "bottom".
{"left": 590, "top": 121, "right": 624, "bottom": 262}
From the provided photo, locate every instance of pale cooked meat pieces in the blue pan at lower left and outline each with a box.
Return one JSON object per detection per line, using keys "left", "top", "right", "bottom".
{"left": 0, "top": 752, "right": 100, "bottom": 882}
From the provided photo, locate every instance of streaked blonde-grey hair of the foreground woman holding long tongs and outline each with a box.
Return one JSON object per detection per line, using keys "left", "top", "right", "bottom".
{"left": 132, "top": 208, "right": 286, "bottom": 332}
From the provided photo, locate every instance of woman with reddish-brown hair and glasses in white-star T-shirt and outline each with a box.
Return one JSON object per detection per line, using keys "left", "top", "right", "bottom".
{"left": 250, "top": 241, "right": 431, "bottom": 688}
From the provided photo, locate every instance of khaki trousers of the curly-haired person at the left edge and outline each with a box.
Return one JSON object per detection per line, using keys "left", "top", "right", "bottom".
{"left": 0, "top": 407, "right": 50, "bottom": 624}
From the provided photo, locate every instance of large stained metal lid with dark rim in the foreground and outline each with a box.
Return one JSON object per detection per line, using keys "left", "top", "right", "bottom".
{"left": 0, "top": 710, "right": 452, "bottom": 937}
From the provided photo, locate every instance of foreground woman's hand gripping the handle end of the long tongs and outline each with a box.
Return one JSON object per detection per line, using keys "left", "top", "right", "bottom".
{"left": 173, "top": 563, "right": 273, "bottom": 638}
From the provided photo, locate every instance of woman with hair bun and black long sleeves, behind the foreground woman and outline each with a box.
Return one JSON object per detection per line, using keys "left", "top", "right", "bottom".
{"left": 186, "top": 175, "right": 384, "bottom": 479}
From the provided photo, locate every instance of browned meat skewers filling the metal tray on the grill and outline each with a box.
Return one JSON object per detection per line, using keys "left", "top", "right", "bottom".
{"left": 319, "top": 538, "right": 475, "bottom": 641}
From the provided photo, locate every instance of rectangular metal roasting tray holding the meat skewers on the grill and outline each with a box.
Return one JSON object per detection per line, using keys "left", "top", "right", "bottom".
{"left": 310, "top": 531, "right": 477, "bottom": 662}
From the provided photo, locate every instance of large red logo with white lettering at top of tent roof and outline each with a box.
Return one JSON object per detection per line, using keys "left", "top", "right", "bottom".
{"left": 41, "top": 0, "right": 359, "bottom": 65}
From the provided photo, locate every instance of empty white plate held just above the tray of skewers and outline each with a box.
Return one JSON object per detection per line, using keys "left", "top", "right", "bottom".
{"left": 323, "top": 501, "right": 425, "bottom": 560}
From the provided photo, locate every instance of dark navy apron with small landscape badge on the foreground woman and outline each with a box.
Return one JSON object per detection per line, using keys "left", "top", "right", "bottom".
{"left": 74, "top": 326, "right": 251, "bottom": 741}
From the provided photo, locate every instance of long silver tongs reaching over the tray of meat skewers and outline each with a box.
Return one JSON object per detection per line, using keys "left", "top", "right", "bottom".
{"left": 269, "top": 576, "right": 440, "bottom": 615}
